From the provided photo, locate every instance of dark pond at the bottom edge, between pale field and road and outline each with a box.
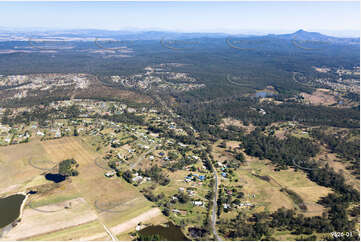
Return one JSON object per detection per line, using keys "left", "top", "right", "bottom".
{"left": 139, "top": 222, "right": 189, "bottom": 241}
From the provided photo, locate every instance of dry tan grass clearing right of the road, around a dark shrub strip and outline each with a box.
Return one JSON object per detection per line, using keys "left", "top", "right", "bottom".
{"left": 238, "top": 157, "right": 331, "bottom": 216}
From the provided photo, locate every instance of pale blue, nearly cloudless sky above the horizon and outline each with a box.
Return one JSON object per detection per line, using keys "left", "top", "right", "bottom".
{"left": 0, "top": 1, "right": 360, "bottom": 36}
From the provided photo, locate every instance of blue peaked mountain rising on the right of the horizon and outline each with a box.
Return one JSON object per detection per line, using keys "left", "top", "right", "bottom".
{"left": 267, "top": 29, "right": 360, "bottom": 44}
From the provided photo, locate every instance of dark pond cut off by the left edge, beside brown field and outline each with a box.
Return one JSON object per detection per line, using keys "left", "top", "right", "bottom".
{"left": 0, "top": 194, "right": 25, "bottom": 228}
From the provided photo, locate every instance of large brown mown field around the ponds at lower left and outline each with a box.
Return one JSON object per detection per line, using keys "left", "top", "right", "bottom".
{"left": 0, "top": 137, "right": 165, "bottom": 240}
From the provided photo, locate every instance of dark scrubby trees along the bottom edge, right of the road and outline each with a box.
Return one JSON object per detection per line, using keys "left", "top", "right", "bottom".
{"left": 219, "top": 208, "right": 359, "bottom": 240}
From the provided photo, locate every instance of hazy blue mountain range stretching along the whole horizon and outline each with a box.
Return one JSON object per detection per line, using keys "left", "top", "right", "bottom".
{"left": 0, "top": 28, "right": 360, "bottom": 44}
